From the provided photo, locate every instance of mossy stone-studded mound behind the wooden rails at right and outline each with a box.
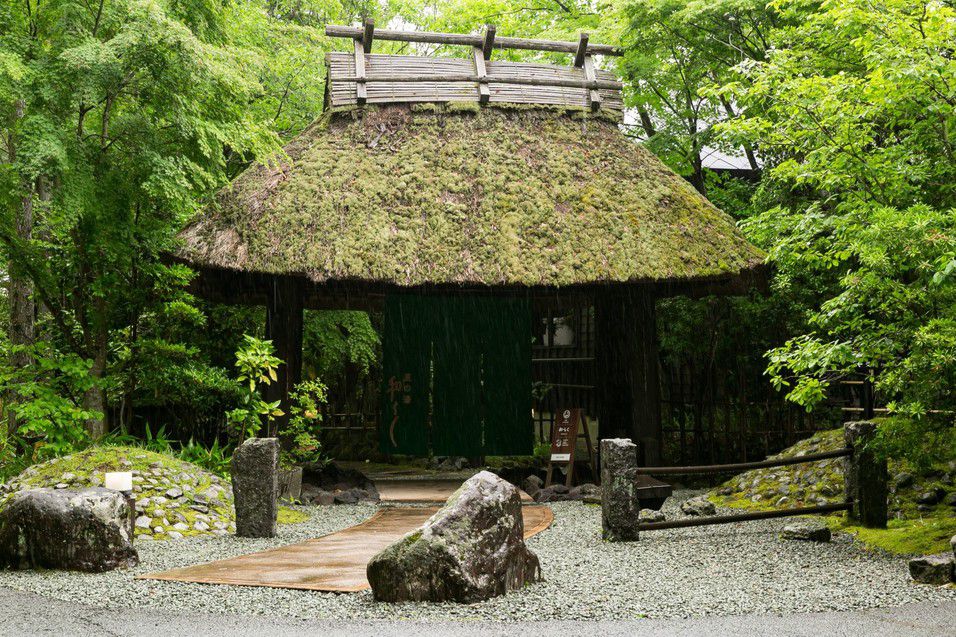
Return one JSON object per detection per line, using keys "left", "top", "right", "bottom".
{"left": 709, "top": 429, "right": 956, "bottom": 554}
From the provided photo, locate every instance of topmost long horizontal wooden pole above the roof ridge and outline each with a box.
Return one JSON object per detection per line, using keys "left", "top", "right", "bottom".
{"left": 325, "top": 24, "right": 623, "bottom": 56}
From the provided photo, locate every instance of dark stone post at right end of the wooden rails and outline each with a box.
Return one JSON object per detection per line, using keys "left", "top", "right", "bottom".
{"left": 843, "top": 421, "right": 888, "bottom": 529}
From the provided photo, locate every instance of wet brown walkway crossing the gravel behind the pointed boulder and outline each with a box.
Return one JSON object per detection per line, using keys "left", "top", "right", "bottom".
{"left": 138, "top": 506, "right": 554, "bottom": 593}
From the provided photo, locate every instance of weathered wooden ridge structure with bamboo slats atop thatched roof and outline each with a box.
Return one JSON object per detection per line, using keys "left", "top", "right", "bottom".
{"left": 325, "top": 20, "right": 623, "bottom": 113}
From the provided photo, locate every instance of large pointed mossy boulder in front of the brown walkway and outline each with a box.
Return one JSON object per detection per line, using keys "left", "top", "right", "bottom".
{"left": 367, "top": 471, "right": 541, "bottom": 603}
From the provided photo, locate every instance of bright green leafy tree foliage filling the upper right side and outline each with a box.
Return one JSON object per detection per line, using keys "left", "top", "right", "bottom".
{"left": 712, "top": 0, "right": 956, "bottom": 424}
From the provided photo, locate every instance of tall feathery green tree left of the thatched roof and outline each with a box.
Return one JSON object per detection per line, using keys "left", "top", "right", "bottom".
{"left": 0, "top": 0, "right": 276, "bottom": 437}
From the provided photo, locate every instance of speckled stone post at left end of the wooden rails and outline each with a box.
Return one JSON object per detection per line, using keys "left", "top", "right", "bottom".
{"left": 601, "top": 438, "right": 640, "bottom": 542}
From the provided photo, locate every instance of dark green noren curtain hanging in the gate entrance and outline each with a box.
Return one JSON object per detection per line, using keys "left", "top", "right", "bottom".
{"left": 380, "top": 294, "right": 533, "bottom": 457}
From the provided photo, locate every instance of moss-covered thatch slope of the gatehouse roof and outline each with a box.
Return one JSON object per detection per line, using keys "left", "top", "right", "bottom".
{"left": 180, "top": 105, "right": 763, "bottom": 286}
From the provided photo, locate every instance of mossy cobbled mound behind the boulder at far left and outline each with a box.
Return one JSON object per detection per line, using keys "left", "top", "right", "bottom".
{"left": 0, "top": 447, "right": 235, "bottom": 539}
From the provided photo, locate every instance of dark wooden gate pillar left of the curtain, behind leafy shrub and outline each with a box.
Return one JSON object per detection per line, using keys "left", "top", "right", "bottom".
{"left": 265, "top": 278, "right": 303, "bottom": 435}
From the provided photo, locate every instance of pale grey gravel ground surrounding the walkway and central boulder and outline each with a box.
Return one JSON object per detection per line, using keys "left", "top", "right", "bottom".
{"left": 0, "top": 492, "right": 956, "bottom": 621}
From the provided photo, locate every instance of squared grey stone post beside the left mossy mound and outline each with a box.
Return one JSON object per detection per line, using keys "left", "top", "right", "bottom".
{"left": 232, "top": 438, "right": 279, "bottom": 537}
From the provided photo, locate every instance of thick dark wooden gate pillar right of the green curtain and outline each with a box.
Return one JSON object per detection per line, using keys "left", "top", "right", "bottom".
{"left": 594, "top": 286, "right": 662, "bottom": 466}
